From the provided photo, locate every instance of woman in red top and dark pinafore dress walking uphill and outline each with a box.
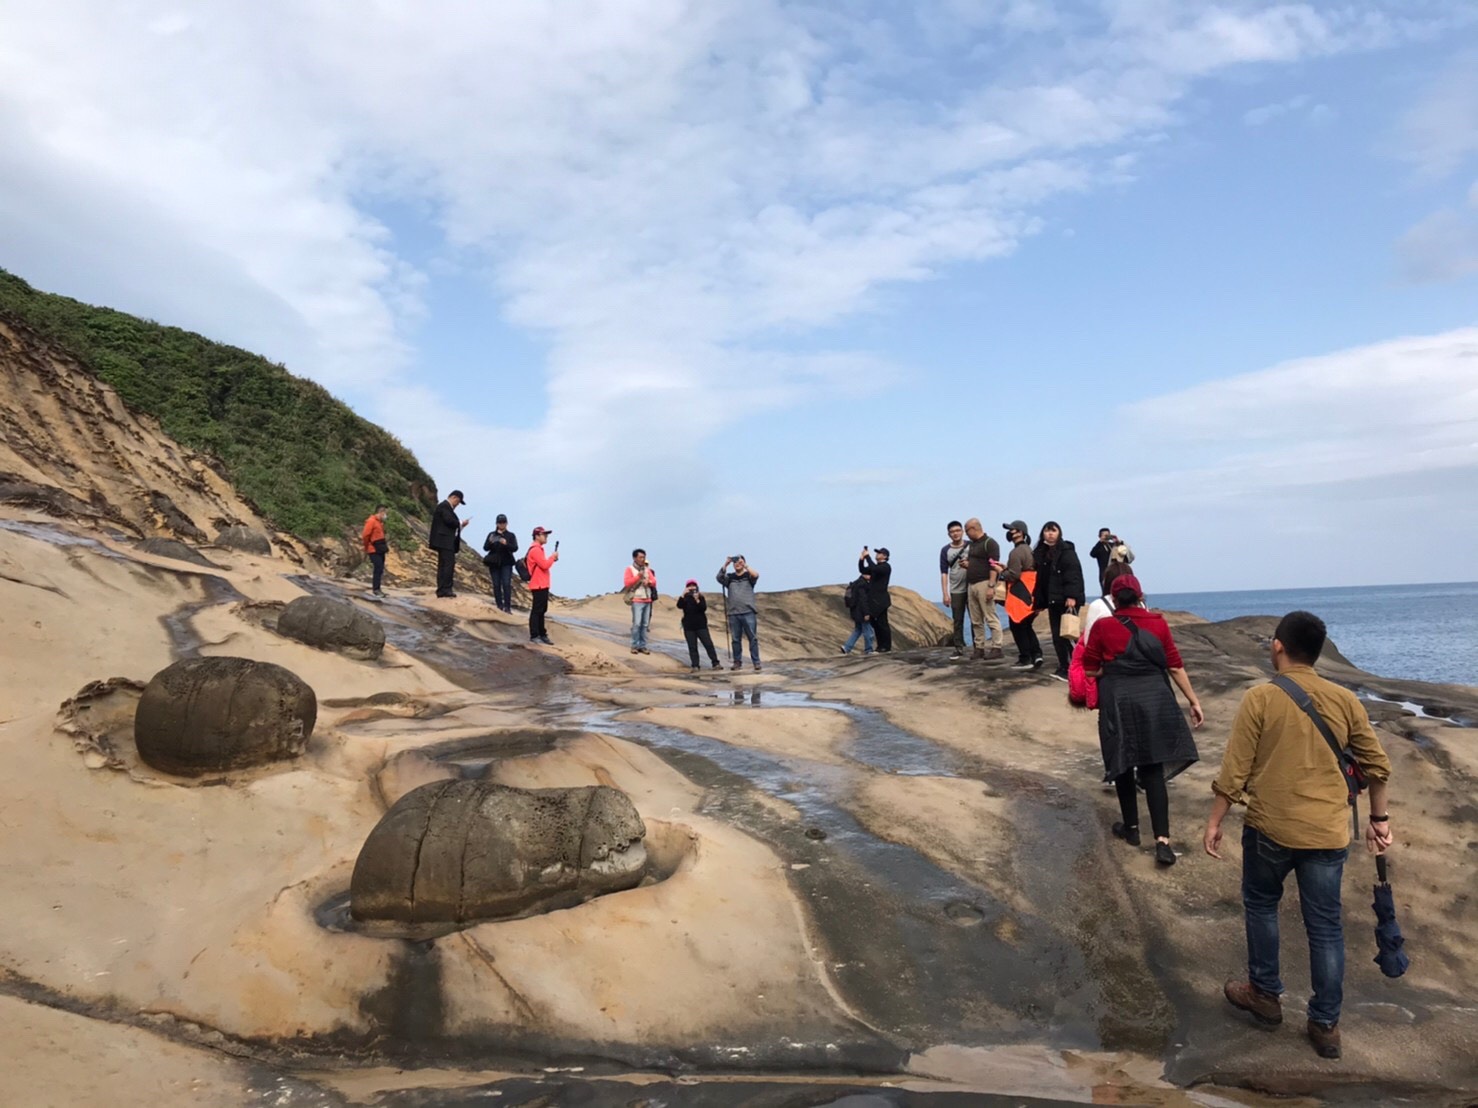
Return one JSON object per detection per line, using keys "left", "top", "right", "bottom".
{"left": 1083, "top": 573, "right": 1206, "bottom": 866}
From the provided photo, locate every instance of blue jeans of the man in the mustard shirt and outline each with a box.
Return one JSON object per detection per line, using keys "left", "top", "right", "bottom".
{"left": 1242, "top": 826, "right": 1349, "bottom": 1025}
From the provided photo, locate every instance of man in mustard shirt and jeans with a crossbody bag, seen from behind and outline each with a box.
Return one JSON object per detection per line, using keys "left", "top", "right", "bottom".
{"left": 1203, "top": 612, "right": 1391, "bottom": 1058}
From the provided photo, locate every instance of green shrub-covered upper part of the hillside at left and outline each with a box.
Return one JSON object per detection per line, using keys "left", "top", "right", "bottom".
{"left": 0, "top": 269, "right": 436, "bottom": 539}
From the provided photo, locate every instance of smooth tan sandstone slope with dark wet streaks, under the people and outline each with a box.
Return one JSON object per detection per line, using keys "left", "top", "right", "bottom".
{"left": 0, "top": 516, "right": 1478, "bottom": 1105}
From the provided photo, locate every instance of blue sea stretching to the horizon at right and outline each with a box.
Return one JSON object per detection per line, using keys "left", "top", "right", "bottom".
{"left": 1148, "top": 581, "right": 1478, "bottom": 685}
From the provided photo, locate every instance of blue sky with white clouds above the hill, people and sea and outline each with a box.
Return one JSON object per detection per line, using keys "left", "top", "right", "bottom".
{"left": 0, "top": 0, "right": 1478, "bottom": 598}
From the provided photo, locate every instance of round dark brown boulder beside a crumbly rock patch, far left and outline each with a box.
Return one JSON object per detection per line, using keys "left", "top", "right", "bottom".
{"left": 133, "top": 657, "right": 318, "bottom": 777}
